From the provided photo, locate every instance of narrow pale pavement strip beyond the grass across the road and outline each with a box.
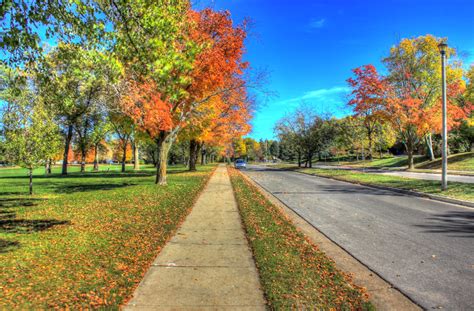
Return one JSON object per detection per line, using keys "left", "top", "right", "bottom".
{"left": 314, "top": 164, "right": 474, "bottom": 184}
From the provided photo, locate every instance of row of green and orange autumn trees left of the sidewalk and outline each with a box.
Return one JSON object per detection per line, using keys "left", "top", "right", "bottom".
{"left": 0, "top": 0, "right": 260, "bottom": 191}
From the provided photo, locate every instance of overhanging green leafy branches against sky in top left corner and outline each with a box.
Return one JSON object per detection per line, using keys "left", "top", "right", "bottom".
{"left": 0, "top": 0, "right": 106, "bottom": 63}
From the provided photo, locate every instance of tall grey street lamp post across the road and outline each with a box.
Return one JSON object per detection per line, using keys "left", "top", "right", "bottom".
{"left": 438, "top": 42, "right": 448, "bottom": 191}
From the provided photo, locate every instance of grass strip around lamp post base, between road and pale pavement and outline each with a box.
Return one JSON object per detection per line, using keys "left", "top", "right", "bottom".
{"left": 297, "top": 168, "right": 474, "bottom": 201}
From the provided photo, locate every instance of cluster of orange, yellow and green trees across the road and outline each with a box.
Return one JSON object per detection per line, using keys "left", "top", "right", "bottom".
{"left": 275, "top": 35, "right": 474, "bottom": 169}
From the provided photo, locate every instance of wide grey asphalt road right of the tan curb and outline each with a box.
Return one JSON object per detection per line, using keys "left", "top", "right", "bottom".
{"left": 244, "top": 166, "right": 474, "bottom": 310}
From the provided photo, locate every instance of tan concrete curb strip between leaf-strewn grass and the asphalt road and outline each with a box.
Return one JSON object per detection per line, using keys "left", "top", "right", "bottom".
{"left": 240, "top": 172, "right": 422, "bottom": 310}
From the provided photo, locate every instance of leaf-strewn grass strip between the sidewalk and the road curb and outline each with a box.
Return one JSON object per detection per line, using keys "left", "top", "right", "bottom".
{"left": 229, "top": 168, "right": 373, "bottom": 310}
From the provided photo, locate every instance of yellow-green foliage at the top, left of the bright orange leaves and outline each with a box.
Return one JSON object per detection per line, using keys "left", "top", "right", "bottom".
{"left": 99, "top": 0, "right": 195, "bottom": 103}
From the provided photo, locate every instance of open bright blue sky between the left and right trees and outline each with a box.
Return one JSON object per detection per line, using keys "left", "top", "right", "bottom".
{"left": 196, "top": 0, "right": 474, "bottom": 140}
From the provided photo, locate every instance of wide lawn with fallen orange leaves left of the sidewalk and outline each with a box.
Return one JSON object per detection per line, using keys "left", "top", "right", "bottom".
{"left": 0, "top": 165, "right": 213, "bottom": 310}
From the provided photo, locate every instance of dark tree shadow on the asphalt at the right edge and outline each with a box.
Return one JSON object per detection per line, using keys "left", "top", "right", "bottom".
{"left": 416, "top": 212, "right": 474, "bottom": 238}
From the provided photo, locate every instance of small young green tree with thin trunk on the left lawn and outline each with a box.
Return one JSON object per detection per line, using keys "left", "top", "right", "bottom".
{"left": 0, "top": 69, "right": 60, "bottom": 194}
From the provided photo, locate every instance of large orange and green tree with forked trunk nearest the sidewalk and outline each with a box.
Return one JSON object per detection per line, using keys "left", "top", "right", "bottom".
{"left": 117, "top": 2, "right": 249, "bottom": 184}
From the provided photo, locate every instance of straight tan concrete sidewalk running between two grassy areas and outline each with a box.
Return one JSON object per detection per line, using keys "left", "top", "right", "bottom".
{"left": 124, "top": 165, "right": 265, "bottom": 310}
